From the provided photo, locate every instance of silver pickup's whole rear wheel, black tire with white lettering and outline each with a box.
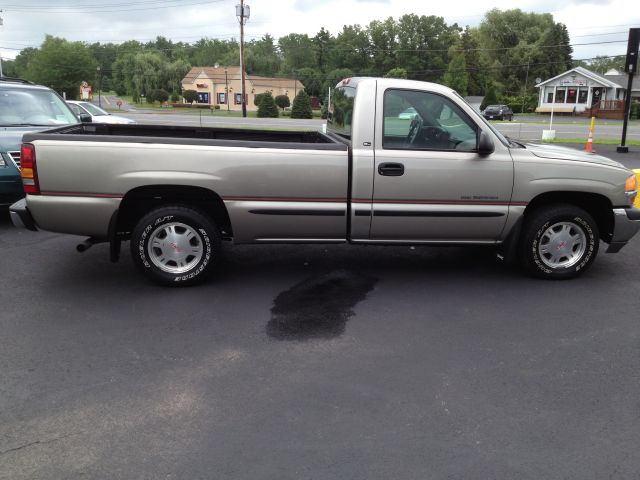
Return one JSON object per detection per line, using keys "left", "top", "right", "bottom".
{"left": 131, "top": 205, "right": 220, "bottom": 286}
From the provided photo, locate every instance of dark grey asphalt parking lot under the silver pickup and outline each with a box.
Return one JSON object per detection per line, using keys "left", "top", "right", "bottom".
{"left": 0, "top": 147, "right": 640, "bottom": 480}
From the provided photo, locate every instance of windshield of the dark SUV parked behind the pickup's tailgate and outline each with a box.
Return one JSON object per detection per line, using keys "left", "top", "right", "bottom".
{"left": 0, "top": 87, "right": 78, "bottom": 127}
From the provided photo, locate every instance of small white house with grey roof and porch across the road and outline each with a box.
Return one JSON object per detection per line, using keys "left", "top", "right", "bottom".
{"left": 536, "top": 67, "right": 640, "bottom": 118}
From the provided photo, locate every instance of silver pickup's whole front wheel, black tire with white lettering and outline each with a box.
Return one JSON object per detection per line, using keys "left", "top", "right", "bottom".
{"left": 520, "top": 204, "right": 600, "bottom": 280}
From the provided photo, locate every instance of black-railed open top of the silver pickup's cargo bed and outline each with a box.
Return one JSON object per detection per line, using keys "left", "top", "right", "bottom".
{"left": 24, "top": 124, "right": 346, "bottom": 150}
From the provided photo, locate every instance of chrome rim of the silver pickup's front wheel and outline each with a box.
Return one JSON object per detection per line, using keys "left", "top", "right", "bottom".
{"left": 538, "top": 222, "right": 587, "bottom": 268}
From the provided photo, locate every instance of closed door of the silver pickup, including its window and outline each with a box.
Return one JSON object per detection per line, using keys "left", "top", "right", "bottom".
{"left": 368, "top": 88, "right": 513, "bottom": 243}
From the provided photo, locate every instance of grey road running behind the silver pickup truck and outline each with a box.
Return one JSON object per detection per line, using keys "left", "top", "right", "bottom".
{"left": 117, "top": 110, "right": 640, "bottom": 143}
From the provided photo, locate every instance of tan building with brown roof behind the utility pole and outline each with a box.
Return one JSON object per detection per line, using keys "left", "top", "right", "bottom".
{"left": 182, "top": 64, "right": 304, "bottom": 111}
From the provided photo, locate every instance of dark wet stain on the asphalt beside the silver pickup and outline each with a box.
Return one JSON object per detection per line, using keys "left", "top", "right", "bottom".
{"left": 267, "top": 270, "right": 377, "bottom": 340}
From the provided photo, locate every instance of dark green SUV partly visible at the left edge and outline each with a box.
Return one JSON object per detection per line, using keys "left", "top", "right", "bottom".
{"left": 0, "top": 77, "right": 78, "bottom": 208}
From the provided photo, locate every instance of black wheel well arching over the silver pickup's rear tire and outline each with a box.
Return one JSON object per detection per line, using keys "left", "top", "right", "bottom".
{"left": 117, "top": 185, "right": 233, "bottom": 238}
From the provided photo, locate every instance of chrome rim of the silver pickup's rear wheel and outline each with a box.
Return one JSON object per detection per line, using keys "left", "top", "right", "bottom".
{"left": 148, "top": 222, "right": 204, "bottom": 274}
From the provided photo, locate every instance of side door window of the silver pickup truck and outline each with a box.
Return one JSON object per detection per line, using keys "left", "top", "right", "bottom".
{"left": 382, "top": 90, "right": 478, "bottom": 152}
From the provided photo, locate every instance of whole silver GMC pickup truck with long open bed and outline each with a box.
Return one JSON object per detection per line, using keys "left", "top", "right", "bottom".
{"left": 11, "top": 78, "right": 640, "bottom": 285}
